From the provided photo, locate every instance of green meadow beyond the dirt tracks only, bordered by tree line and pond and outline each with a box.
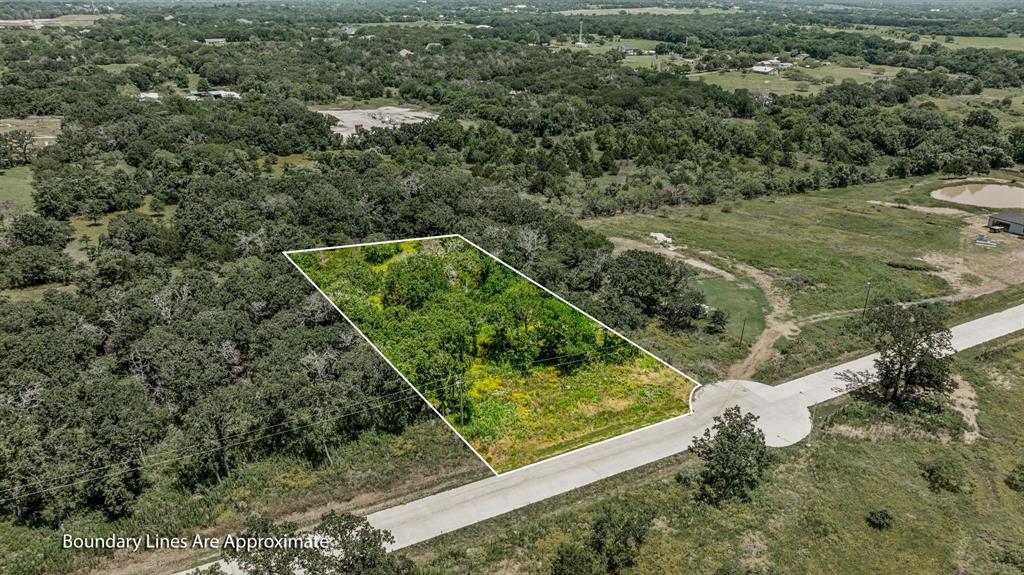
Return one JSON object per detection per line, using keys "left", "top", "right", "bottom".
{"left": 583, "top": 177, "right": 963, "bottom": 317}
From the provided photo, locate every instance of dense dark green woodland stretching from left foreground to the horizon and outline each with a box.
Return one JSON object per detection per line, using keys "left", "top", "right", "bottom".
{"left": 0, "top": 0, "right": 1024, "bottom": 574}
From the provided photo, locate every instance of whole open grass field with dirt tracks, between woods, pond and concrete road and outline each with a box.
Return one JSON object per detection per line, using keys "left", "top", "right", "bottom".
{"left": 582, "top": 172, "right": 1024, "bottom": 384}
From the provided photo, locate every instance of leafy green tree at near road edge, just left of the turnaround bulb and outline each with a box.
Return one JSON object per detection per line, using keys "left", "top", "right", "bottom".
{"left": 690, "top": 406, "right": 775, "bottom": 503}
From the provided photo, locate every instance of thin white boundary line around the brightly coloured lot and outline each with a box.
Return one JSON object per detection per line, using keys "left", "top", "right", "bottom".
{"left": 283, "top": 233, "right": 701, "bottom": 477}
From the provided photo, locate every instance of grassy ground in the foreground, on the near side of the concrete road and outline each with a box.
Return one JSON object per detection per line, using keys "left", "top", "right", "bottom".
{"left": 408, "top": 338, "right": 1024, "bottom": 575}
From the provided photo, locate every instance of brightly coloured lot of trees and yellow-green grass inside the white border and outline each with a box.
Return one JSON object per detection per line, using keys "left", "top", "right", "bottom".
{"left": 290, "top": 237, "right": 696, "bottom": 472}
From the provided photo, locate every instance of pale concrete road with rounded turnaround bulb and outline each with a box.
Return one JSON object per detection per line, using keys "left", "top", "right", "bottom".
{"left": 179, "top": 305, "right": 1024, "bottom": 575}
